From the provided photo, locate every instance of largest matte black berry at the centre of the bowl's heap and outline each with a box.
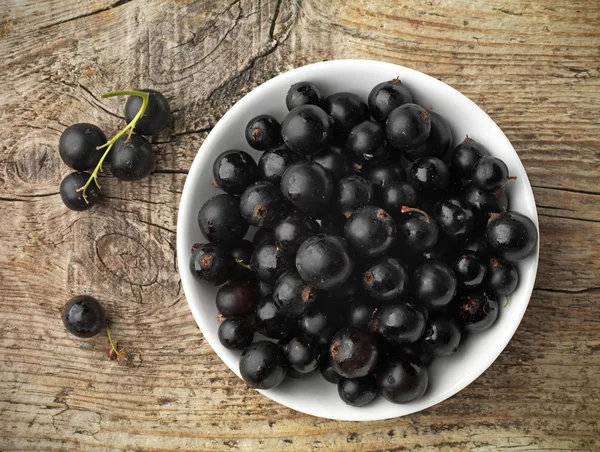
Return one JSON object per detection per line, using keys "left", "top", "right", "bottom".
{"left": 296, "top": 234, "right": 354, "bottom": 290}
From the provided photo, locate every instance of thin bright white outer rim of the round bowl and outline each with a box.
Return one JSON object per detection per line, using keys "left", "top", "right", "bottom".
{"left": 176, "top": 59, "right": 540, "bottom": 421}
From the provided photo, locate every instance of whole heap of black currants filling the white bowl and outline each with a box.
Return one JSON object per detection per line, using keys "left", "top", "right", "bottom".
{"left": 190, "top": 79, "right": 537, "bottom": 406}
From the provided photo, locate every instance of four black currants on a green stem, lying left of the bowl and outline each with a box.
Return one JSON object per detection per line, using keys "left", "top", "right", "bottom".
{"left": 58, "top": 89, "right": 170, "bottom": 210}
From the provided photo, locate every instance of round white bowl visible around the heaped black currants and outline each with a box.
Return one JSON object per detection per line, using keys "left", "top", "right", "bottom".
{"left": 177, "top": 60, "right": 539, "bottom": 421}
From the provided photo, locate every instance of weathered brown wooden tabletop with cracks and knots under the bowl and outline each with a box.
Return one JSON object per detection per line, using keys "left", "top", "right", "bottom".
{"left": 0, "top": 0, "right": 600, "bottom": 451}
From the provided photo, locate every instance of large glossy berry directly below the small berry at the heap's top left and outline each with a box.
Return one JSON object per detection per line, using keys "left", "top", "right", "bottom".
{"left": 281, "top": 104, "right": 331, "bottom": 155}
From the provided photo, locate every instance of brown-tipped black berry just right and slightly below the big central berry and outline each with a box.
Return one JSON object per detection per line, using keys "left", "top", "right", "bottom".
{"left": 361, "top": 256, "right": 408, "bottom": 300}
